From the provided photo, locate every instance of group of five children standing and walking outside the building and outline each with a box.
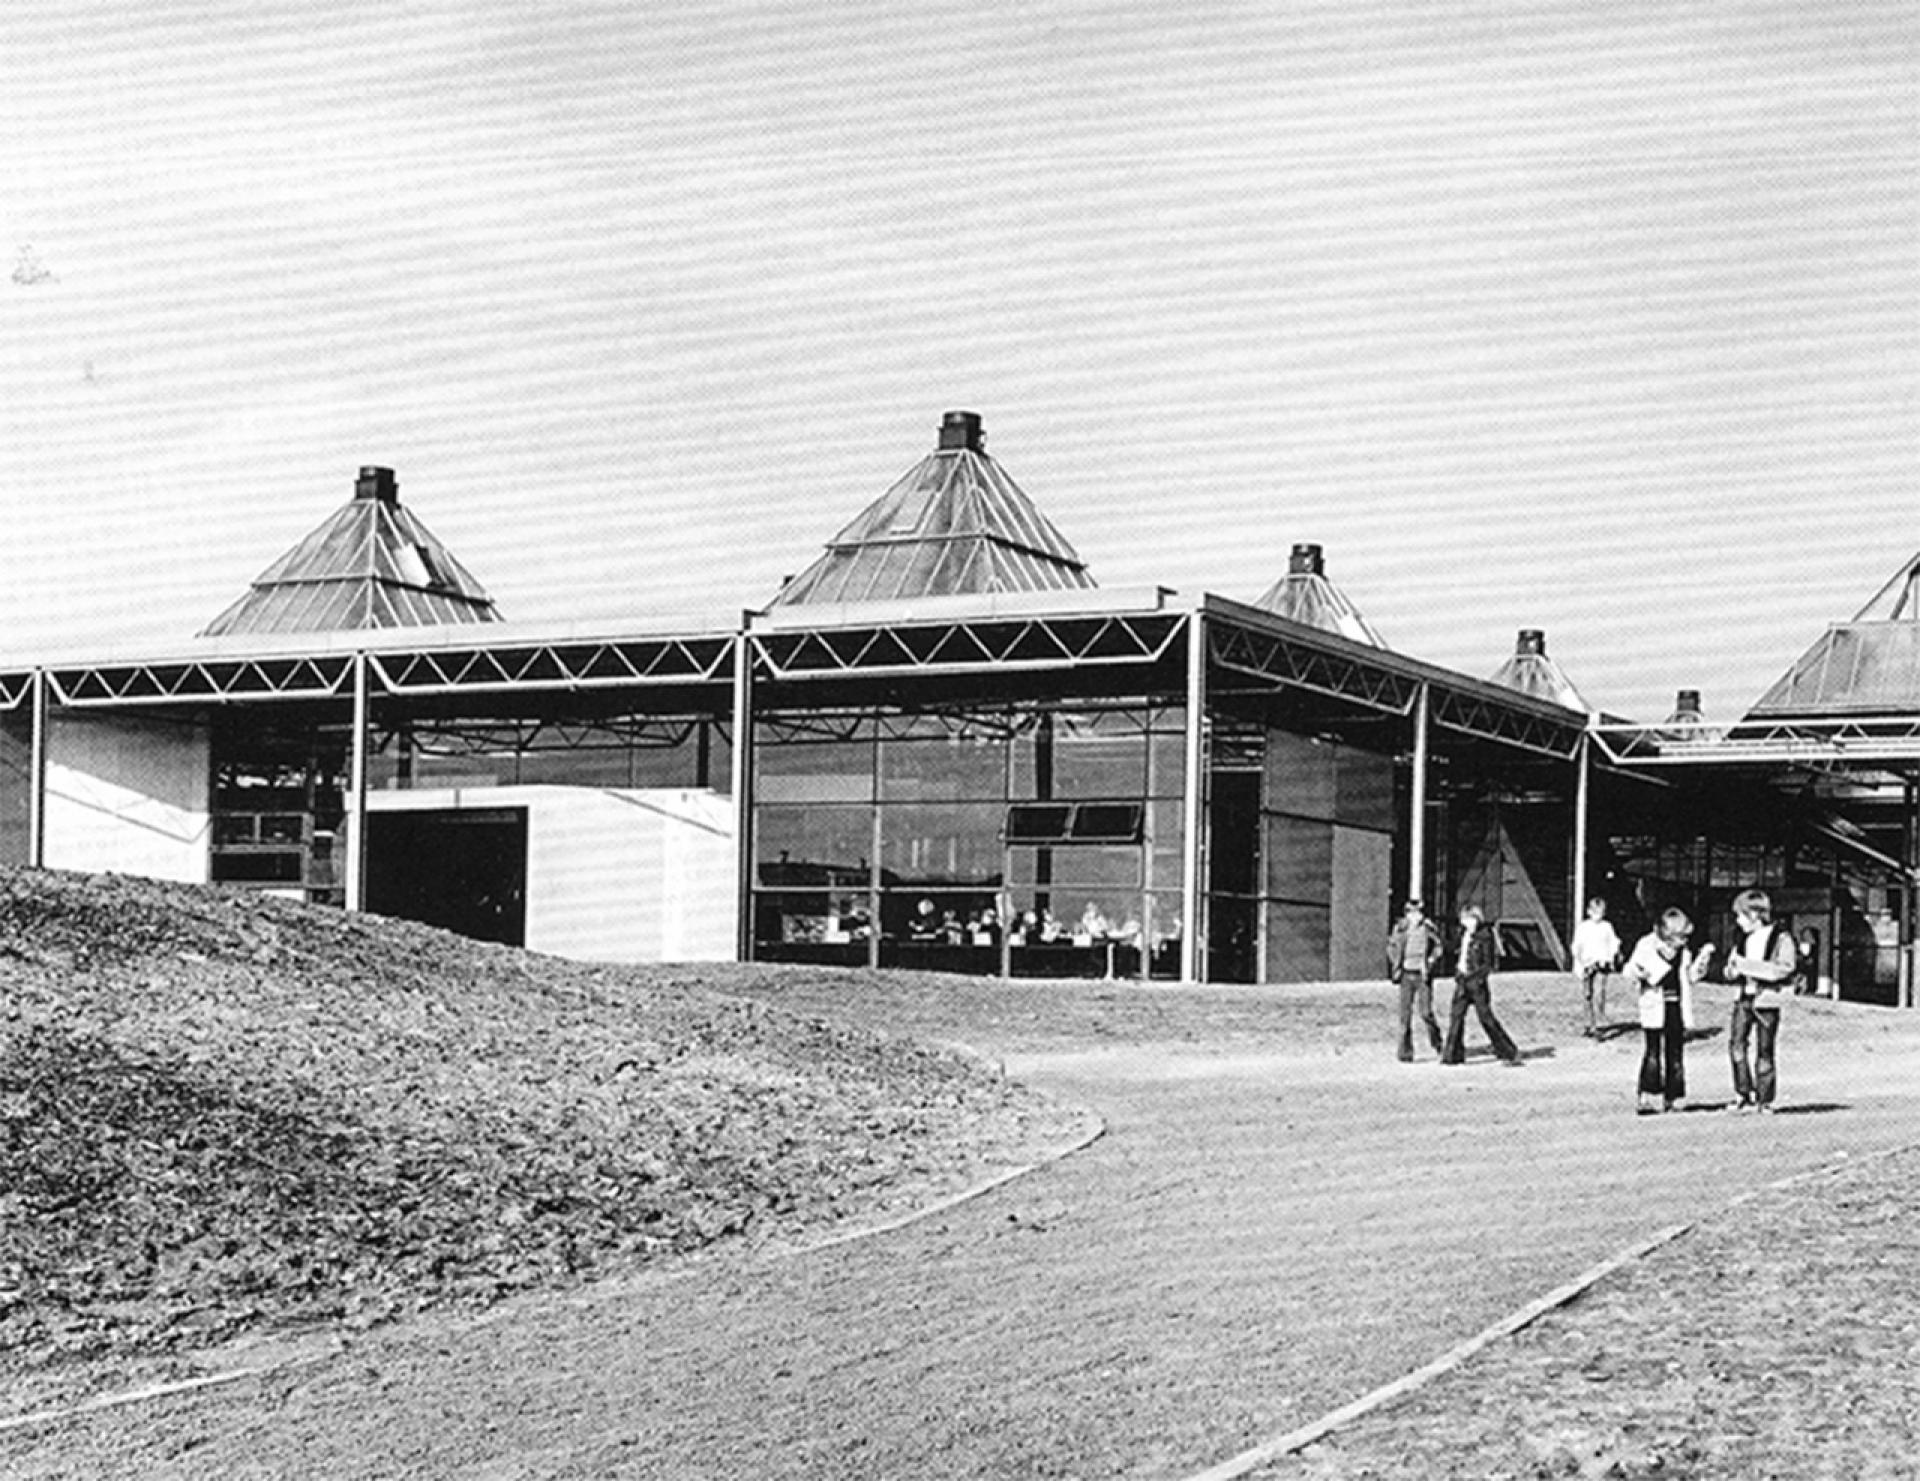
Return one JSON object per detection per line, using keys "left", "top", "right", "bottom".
{"left": 1386, "top": 889, "right": 1807, "bottom": 1116}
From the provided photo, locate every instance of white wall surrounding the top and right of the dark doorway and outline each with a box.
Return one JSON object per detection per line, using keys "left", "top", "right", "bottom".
{"left": 367, "top": 786, "right": 737, "bottom": 962}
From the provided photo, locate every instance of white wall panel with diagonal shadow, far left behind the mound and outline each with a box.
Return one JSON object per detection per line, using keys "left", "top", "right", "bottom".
{"left": 46, "top": 711, "right": 213, "bottom": 884}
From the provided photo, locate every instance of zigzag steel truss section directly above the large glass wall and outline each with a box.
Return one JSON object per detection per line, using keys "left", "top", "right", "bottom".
{"left": 751, "top": 615, "right": 1187, "bottom": 678}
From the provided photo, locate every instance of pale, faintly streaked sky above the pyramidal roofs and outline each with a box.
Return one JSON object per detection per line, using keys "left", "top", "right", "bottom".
{"left": 0, "top": 0, "right": 1920, "bottom": 718}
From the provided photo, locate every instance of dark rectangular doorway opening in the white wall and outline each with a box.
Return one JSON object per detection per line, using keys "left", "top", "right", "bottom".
{"left": 367, "top": 807, "right": 526, "bottom": 947}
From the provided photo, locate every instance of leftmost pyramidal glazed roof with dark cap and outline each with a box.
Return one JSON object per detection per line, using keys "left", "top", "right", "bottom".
{"left": 200, "top": 469, "right": 499, "bottom": 638}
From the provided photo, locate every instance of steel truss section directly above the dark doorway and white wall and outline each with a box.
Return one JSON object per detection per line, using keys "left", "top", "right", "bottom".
{"left": 369, "top": 638, "right": 733, "bottom": 693}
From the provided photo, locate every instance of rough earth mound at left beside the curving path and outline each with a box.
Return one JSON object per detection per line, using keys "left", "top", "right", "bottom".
{"left": 0, "top": 870, "right": 1046, "bottom": 1362}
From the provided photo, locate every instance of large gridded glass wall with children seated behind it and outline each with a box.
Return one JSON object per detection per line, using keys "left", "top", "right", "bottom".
{"left": 751, "top": 703, "right": 1185, "bottom": 976}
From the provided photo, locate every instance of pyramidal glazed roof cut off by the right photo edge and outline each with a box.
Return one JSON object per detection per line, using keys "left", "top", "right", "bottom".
{"left": 1749, "top": 555, "right": 1920, "bottom": 716}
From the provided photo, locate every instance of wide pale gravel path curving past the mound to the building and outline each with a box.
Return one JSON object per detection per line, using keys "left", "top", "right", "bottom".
{"left": 0, "top": 974, "right": 1920, "bottom": 1479}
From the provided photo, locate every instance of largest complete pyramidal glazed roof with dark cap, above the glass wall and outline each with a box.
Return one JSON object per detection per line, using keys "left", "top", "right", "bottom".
{"left": 772, "top": 411, "right": 1094, "bottom": 607}
